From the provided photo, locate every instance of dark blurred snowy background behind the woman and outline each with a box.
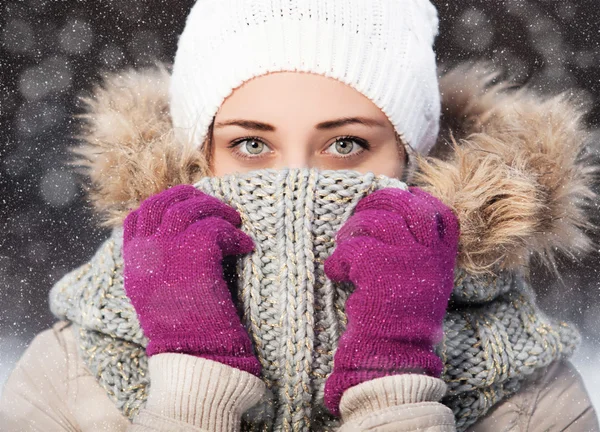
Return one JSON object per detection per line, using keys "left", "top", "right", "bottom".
{"left": 0, "top": 0, "right": 600, "bottom": 410}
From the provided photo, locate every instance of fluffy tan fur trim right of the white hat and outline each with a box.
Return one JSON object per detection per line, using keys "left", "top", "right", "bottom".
{"left": 415, "top": 64, "right": 595, "bottom": 273}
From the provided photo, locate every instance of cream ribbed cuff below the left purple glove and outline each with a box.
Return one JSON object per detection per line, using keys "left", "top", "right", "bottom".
{"left": 146, "top": 353, "right": 265, "bottom": 431}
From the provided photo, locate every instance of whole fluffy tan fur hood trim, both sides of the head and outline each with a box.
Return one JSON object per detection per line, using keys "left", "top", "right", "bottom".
{"left": 71, "top": 64, "right": 595, "bottom": 273}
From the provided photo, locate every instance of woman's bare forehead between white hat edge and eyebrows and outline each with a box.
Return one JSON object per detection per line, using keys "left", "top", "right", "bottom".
{"left": 217, "top": 72, "right": 386, "bottom": 119}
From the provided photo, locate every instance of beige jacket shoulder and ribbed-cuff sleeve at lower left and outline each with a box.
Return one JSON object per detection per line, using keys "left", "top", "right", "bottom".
{"left": 0, "top": 321, "right": 264, "bottom": 432}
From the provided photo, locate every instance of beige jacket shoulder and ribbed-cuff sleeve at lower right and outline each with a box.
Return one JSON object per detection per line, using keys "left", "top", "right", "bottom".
{"left": 340, "top": 361, "right": 600, "bottom": 432}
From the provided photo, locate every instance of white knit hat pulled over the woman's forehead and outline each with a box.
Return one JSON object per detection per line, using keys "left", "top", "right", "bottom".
{"left": 170, "top": 0, "right": 440, "bottom": 153}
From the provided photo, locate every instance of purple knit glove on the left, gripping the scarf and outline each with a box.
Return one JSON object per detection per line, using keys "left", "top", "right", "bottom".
{"left": 123, "top": 185, "right": 260, "bottom": 376}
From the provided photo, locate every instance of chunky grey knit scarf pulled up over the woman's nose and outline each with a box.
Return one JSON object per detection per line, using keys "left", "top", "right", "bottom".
{"left": 50, "top": 169, "right": 579, "bottom": 431}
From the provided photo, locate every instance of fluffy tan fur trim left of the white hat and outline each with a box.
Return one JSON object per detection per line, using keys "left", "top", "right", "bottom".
{"left": 70, "top": 66, "right": 208, "bottom": 227}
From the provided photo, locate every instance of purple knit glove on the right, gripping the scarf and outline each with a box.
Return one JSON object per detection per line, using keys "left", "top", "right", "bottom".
{"left": 325, "top": 187, "right": 459, "bottom": 416}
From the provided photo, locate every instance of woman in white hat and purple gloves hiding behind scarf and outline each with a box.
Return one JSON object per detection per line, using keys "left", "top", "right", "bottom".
{"left": 0, "top": 0, "right": 598, "bottom": 431}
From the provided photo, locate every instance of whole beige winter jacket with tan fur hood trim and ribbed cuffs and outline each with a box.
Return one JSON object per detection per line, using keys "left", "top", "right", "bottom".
{"left": 0, "top": 61, "right": 600, "bottom": 431}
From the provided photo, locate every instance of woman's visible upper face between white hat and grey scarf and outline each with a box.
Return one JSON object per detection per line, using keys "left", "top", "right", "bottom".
{"left": 208, "top": 72, "right": 405, "bottom": 178}
